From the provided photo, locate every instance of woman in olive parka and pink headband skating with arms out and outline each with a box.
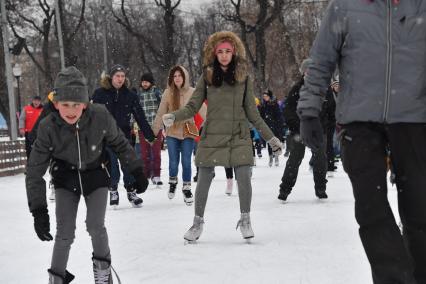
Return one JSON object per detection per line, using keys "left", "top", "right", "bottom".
{"left": 163, "top": 31, "right": 282, "bottom": 241}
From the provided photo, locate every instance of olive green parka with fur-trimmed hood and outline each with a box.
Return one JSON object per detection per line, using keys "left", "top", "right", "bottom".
{"left": 173, "top": 31, "right": 274, "bottom": 167}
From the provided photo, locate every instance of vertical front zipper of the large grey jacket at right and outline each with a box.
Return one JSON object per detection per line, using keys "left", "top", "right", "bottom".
{"left": 383, "top": 0, "right": 392, "bottom": 122}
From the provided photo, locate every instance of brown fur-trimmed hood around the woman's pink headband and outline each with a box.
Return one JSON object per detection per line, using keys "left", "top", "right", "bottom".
{"left": 203, "top": 31, "right": 247, "bottom": 85}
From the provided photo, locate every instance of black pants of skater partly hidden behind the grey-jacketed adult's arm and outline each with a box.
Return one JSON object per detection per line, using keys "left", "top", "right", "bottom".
{"left": 280, "top": 134, "right": 327, "bottom": 194}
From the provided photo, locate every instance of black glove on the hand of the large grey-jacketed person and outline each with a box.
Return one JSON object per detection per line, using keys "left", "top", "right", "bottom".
{"left": 300, "top": 117, "right": 324, "bottom": 152}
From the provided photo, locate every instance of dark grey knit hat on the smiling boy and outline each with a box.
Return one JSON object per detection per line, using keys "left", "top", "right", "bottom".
{"left": 53, "top": 66, "right": 89, "bottom": 103}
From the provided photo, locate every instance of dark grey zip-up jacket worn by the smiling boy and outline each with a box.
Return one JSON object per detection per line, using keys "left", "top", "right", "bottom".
{"left": 25, "top": 104, "right": 142, "bottom": 211}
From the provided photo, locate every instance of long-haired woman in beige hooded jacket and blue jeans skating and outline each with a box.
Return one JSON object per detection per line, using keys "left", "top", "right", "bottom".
{"left": 153, "top": 65, "right": 206, "bottom": 205}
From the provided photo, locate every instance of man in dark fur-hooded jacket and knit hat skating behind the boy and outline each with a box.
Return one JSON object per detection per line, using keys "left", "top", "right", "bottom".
{"left": 92, "top": 65, "right": 155, "bottom": 207}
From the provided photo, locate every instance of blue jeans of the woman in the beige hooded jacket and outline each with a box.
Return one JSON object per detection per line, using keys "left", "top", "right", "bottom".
{"left": 166, "top": 137, "right": 194, "bottom": 182}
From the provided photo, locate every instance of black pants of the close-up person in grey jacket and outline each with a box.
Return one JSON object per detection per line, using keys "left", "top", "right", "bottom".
{"left": 342, "top": 123, "right": 426, "bottom": 284}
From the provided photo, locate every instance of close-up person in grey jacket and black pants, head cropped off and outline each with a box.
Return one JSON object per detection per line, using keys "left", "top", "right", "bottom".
{"left": 298, "top": 0, "right": 426, "bottom": 284}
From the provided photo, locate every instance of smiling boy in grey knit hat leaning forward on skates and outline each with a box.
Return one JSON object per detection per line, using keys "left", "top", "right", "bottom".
{"left": 25, "top": 67, "right": 148, "bottom": 284}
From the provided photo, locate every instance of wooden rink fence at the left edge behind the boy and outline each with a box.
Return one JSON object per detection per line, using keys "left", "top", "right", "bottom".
{"left": 0, "top": 140, "right": 27, "bottom": 177}
